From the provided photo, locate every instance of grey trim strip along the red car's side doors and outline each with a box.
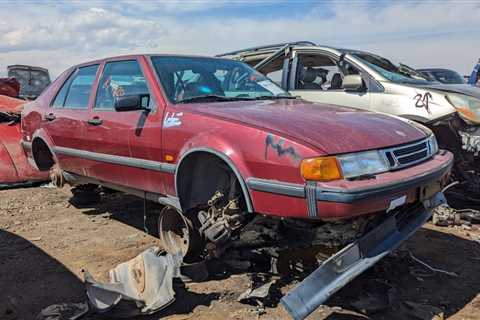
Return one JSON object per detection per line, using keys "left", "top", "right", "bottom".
{"left": 53, "top": 147, "right": 176, "bottom": 174}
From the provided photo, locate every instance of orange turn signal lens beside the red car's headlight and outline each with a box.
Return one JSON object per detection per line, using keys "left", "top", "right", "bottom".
{"left": 300, "top": 157, "right": 342, "bottom": 181}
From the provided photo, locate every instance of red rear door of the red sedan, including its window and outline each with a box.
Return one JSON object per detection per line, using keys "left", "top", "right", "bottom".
{"left": 44, "top": 64, "right": 99, "bottom": 175}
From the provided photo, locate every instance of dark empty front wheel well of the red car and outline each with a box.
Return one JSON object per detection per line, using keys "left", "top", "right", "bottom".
{"left": 176, "top": 151, "right": 249, "bottom": 212}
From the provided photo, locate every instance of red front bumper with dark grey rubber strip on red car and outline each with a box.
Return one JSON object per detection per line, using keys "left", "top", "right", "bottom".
{"left": 247, "top": 150, "right": 453, "bottom": 219}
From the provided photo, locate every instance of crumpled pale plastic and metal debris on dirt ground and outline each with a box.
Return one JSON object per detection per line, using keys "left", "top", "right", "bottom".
{"left": 85, "top": 247, "right": 182, "bottom": 316}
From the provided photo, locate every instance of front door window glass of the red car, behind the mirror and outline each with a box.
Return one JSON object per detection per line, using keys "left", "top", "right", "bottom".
{"left": 95, "top": 60, "right": 152, "bottom": 109}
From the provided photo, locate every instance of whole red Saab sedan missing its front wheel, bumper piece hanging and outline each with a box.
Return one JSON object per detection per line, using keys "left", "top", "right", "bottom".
{"left": 22, "top": 55, "right": 453, "bottom": 317}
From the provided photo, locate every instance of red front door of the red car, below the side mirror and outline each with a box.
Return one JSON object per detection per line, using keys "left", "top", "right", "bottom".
{"left": 85, "top": 58, "right": 164, "bottom": 193}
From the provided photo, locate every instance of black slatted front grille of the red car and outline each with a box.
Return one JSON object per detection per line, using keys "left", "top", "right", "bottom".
{"left": 382, "top": 138, "right": 433, "bottom": 169}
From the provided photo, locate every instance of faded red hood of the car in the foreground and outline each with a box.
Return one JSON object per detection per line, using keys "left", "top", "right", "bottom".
{"left": 178, "top": 99, "right": 426, "bottom": 154}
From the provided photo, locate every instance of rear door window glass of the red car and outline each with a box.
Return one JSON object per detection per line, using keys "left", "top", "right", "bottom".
{"left": 64, "top": 65, "right": 98, "bottom": 109}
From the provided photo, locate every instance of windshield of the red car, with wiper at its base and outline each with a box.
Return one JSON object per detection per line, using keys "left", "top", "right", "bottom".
{"left": 152, "top": 56, "right": 291, "bottom": 103}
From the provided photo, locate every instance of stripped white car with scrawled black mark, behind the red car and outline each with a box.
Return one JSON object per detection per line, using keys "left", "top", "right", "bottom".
{"left": 217, "top": 41, "right": 480, "bottom": 199}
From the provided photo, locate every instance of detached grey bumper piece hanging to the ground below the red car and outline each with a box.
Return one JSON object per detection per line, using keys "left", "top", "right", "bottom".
{"left": 281, "top": 193, "right": 445, "bottom": 320}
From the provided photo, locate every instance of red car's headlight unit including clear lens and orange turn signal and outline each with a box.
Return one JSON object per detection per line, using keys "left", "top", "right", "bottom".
{"left": 300, "top": 151, "right": 389, "bottom": 181}
